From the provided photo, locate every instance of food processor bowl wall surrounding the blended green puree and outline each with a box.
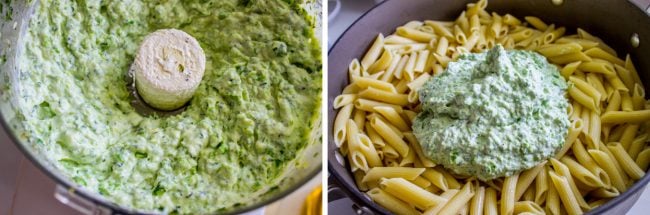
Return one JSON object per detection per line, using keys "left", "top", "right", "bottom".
{"left": 0, "top": 0, "right": 322, "bottom": 214}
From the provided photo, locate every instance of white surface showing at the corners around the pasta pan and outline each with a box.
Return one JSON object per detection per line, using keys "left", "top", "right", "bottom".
{"left": 328, "top": 0, "right": 650, "bottom": 215}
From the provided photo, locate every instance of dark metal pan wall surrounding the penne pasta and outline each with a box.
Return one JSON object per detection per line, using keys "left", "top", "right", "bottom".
{"left": 327, "top": 0, "right": 650, "bottom": 214}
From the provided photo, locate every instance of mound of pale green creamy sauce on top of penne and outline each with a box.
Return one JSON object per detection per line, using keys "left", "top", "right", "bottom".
{"left": 413, "top": 45, "right": 569, "bottom": 180}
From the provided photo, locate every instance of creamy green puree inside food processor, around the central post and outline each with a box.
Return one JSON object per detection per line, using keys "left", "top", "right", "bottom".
{"left": 11, "top": 0, "right": 322, "bottom": 214}
